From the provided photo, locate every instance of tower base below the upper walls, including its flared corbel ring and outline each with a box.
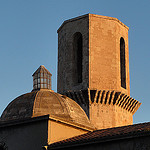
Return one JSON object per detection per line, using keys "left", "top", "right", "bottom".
{"left": 64, "top": 89, "right": 141, "bottom": 129}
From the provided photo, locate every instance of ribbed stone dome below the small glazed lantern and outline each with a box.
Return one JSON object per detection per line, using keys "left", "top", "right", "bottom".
{"left": 1, "top": 89, "right": 91, "bottom": 127}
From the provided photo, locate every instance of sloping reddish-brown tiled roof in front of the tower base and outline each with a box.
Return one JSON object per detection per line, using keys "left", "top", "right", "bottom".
{"left": 49, "top": 122, "right": 150, "bottom": 148}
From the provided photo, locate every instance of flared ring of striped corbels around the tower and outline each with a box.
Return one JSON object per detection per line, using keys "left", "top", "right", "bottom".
{"left": 64, "top": 89, "right": 141, "bottom": 114}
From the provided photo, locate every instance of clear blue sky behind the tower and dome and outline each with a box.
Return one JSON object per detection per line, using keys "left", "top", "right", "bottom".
{"left": 0, "top": 0, "right": 150, "bottom": 123}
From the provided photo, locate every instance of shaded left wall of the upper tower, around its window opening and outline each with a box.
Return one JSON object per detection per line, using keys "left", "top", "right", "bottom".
{"left": 57, "top": 15, "right": 89, "bottom": 93}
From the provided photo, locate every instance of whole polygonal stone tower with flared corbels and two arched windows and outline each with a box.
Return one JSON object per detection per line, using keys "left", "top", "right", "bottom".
{"left": 57, "top": 14, "right": 141, "bottom": 129}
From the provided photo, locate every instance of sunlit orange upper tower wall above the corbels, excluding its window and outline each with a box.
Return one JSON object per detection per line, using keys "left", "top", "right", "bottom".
{"left": 89, "top": 14, "right": 130, "bottom": 95}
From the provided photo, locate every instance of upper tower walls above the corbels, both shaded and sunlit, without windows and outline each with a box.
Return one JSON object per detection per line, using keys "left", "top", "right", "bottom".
{"left": 57, "top": 14, "right": 130, "bottom": 95}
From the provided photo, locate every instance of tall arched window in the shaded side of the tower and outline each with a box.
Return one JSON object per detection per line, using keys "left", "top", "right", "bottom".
{"left": 73, "top": 32, "right": 83, "bottom": 83}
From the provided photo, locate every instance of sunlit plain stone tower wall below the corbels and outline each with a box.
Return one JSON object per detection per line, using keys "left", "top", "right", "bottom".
{"left": 90, "top": 103, "right": 133, "bottom": 129}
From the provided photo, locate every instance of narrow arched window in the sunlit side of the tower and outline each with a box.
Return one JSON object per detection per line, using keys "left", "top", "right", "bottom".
{"left": 120, "top": 37, "right": 126, "bottom": 89}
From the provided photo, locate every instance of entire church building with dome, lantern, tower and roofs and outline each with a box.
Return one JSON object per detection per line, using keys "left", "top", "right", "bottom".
{"left": 0, "top": 14, "right": 150, "bottom": 150}
